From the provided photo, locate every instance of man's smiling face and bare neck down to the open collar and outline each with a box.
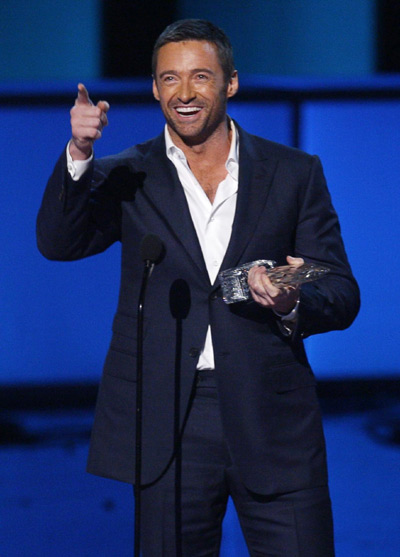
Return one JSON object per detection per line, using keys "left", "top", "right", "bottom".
{"left": 153, "top": 37, "right": 238, "bottom": 203}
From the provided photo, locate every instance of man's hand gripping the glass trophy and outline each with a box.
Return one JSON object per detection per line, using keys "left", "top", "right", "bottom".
{"left": 247, "top": 255, "right": 304, "bottom": 314}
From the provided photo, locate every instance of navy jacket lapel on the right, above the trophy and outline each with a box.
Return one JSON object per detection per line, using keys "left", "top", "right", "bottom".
{"left": 217, "top": 124, "right": 277, "bottom": 278}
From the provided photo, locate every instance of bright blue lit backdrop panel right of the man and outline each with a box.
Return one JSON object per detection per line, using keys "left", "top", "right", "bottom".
{"left": 301, "top": 100, "right": 400, "bottom": 376}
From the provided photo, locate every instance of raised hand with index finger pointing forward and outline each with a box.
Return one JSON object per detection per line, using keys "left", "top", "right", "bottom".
{"left": 69, "top": 83, "right": 110, "bottom": 160}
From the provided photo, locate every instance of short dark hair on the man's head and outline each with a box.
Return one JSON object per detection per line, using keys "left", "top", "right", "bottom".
{"left": 152, "top": 19, "right": 235, "bottom": 81}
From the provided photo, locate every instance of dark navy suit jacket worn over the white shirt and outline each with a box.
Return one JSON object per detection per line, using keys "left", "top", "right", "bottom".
{"left": 37, "top": 124, "right": 359, "bottom": 494}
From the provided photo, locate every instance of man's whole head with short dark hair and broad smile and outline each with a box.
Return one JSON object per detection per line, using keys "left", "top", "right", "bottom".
{"left": 153, "top": 20, "right": 238, "bottom": 145}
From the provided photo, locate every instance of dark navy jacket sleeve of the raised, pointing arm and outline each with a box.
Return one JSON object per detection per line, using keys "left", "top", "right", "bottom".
{"left": 36, "top": 148, "right": 121, "bottom": 261}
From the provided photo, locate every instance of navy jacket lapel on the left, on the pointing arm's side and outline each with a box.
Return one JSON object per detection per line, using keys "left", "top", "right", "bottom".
{"left": 143, "top": 134, "right": 209, "bottom": 282}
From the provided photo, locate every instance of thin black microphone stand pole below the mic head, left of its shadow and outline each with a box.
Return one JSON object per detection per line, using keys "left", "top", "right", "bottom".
{"left": 134, "top": 259, "right": 154, "bottom": 557}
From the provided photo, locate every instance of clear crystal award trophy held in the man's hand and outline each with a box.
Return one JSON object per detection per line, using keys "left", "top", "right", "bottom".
{"left": 218, "top": 259, "right": 330, "bottom": 304}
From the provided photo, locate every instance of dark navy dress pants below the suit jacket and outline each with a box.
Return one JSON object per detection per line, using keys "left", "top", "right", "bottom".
{"left": 141, "top": 371, "right": 334, "bottom": 557}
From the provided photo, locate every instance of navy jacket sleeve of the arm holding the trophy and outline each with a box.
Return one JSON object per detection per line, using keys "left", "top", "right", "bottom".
{"left": 293, "top": 157, "right": 360, "bottom": 340}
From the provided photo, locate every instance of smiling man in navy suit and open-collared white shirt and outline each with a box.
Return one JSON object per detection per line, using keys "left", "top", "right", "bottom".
{"left": 37, "top": 20, "right": 359, "bottom": 557}
